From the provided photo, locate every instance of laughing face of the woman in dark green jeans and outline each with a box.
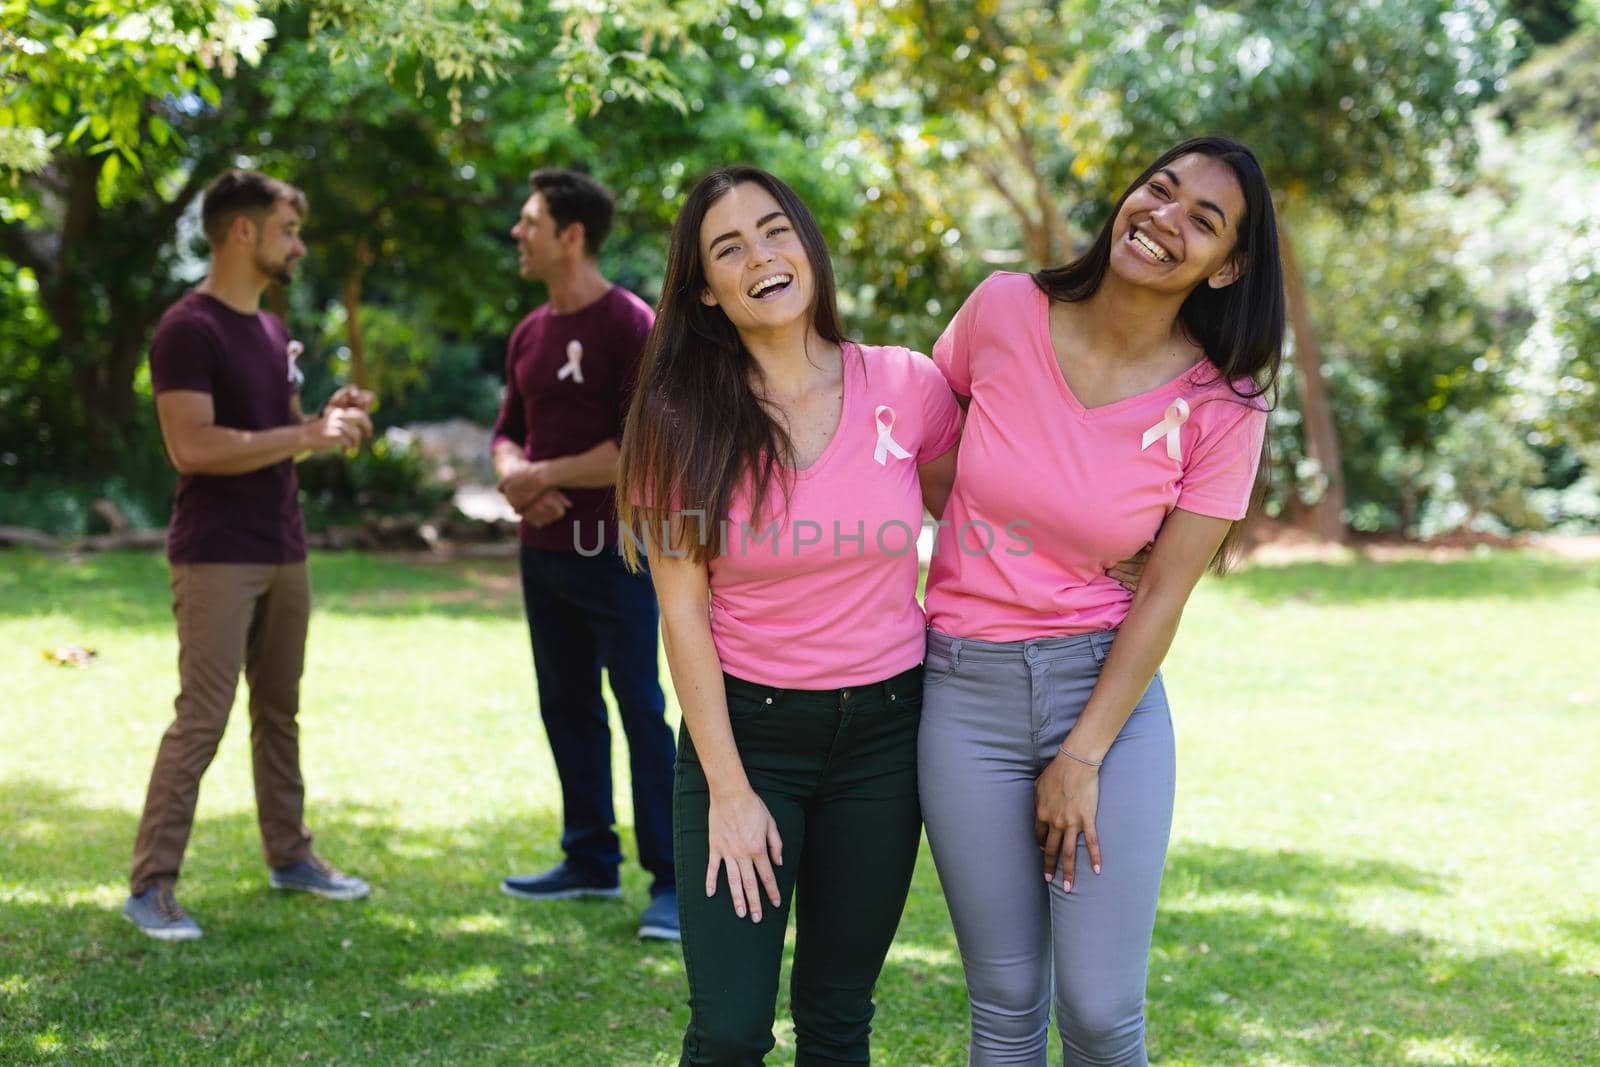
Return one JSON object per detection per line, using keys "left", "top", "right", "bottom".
{"left": 699, "top": 182, "right": 816, "bottom": 333}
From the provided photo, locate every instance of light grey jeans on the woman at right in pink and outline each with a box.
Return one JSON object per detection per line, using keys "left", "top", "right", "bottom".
{"left": 918, "top": 630, "right": 1176, "bottom": 1067}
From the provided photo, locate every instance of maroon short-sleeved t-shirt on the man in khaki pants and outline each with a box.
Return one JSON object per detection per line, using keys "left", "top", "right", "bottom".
{"left": 150, "top": 291, "right": 306, "bottom": 563}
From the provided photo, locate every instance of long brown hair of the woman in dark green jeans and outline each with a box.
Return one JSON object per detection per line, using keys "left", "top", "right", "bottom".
{"left": 616, "top": 165, "right": 846, "bottom": 569}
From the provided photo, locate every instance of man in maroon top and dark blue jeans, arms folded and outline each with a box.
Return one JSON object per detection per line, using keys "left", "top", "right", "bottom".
{"left": 494, "top": 170, "right": 678, "bottom": 941}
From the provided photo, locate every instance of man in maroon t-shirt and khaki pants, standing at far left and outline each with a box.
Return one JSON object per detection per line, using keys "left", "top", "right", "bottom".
{"left": 123, "top": 170, "right": 373, "bottom": 941}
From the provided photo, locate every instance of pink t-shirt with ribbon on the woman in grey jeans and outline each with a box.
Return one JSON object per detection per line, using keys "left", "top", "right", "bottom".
{"left": 928, "top": 272, "right": 1267, "bottom": 641}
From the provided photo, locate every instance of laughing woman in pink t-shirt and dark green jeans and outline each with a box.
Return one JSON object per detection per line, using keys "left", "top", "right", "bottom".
{"left": 618, "top": 166, "right": 960, "bottom": 1064}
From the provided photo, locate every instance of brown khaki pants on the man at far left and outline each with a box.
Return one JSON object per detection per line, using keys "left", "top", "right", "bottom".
{"left": 130, "top": 563, "right": 310, "bottom": 893}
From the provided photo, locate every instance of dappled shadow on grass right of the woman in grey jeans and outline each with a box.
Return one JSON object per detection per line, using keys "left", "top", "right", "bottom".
{"left": 890, "top": 848, "right": 1600, "bottom": 1067}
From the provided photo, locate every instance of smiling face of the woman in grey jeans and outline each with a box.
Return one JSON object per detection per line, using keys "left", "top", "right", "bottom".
{"left": 1110, "top": 154, "right": 1245, "bottom": 293}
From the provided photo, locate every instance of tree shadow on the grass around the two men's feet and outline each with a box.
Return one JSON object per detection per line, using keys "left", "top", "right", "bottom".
{"left": 0, "top": 779, "right": 686, "bottom": 1064}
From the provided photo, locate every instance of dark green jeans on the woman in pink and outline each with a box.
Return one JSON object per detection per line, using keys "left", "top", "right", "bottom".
{"left": 672, "top": 667, "right": 922, "bottom": 1065}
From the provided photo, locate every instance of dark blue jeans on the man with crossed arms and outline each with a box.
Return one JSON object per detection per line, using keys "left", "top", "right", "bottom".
{"left": 522, "top": 545, "right": 677, "bottom": 893}
